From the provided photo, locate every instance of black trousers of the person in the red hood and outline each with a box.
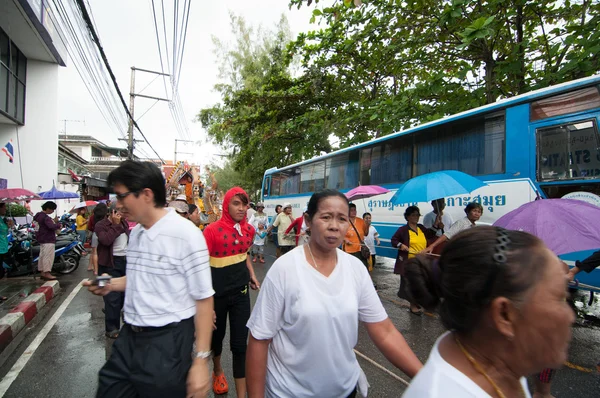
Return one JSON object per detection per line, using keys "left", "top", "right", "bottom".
{"left": 211, "top": 285, "right": 250, "bottom": 379}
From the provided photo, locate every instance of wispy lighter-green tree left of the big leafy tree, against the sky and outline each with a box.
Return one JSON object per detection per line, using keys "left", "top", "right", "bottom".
{"left": 197, "top": 16, "right": 333, "bottom": 190}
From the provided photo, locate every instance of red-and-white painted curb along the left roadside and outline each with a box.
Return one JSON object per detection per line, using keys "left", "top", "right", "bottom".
{"left": 0, "top": 281, "right": 60, "bottom": 352}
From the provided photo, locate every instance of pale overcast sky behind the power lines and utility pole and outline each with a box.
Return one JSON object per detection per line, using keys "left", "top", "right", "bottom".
{"left": 58, "top": 0, "right": 314, "bottom": 166}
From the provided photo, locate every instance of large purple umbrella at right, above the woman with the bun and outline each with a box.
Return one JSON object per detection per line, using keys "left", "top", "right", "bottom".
{"left": 494, "top": 199, "right": 600, "bottom": 255}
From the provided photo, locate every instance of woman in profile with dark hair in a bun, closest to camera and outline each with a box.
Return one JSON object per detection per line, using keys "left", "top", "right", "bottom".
{"left": 403, "top": 226, "right": 575, "bottom": 398}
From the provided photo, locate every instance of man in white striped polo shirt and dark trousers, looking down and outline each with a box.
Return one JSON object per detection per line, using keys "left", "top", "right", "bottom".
{"left": 84, "top": 161, "right": 214, "bottom": 398}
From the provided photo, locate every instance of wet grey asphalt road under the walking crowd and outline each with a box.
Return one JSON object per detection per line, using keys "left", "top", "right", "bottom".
{"left": 0, "top": 248, "right": 600, "bottom": 398}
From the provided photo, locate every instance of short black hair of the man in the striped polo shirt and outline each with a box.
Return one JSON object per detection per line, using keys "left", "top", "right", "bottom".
{"left": 108, "top": 160, "right": 167, "bottom": 208}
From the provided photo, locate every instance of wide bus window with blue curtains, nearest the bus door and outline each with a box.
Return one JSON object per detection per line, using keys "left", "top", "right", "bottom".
{"left": 416, "top": 112, "right": 505, "bottom": 175}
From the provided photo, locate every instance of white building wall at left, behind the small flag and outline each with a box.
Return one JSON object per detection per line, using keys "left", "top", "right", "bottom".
{"left": 0, "top": 60, "right": 60, "bottom": 211}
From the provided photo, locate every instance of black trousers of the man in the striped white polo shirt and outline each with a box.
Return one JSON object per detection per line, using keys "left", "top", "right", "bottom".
{"left": 96, "top": 317, "right": 194, "bottom": 398}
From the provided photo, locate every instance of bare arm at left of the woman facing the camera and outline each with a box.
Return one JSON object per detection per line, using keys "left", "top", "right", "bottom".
{"left": 246, "top": 333, "right": 271, "bottom": 398}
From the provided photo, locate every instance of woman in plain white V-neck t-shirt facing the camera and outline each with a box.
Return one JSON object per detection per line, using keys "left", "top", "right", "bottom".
{"left": 246, "top": 190, "right": 422, "bottom": 398}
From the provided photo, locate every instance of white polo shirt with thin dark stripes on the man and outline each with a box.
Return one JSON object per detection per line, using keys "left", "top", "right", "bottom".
{"left": 124, "top": 210, "right": 215, "bottom": 326}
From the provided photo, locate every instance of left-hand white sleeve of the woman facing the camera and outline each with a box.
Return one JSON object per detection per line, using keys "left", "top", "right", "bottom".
{"left": 246, "top": 274, "right": 285, "bottom": 340}
